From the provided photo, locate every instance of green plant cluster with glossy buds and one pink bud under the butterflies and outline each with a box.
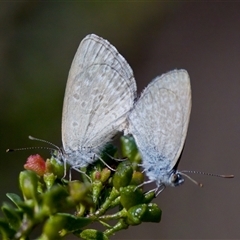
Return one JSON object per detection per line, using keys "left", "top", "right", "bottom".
{"left": 0, "top": 137, "right": 161, "bottom": 240}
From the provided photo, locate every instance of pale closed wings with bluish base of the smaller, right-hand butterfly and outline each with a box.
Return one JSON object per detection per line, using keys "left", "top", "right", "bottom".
{"left": 129, "top": 70, "right": 191, "bottom": 176}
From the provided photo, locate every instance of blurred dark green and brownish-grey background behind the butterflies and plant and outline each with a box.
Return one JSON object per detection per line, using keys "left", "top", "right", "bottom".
{"left": 0, "top": 1, "right": 240, "bottom": 239}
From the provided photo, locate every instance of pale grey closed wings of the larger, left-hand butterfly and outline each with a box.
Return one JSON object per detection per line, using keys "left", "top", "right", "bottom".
{"left": 62, "top": 34, "right": 136, "bottom": 152}
